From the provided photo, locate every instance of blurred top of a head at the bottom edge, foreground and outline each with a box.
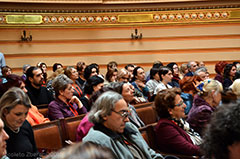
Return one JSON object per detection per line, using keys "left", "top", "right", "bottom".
{"left": 45, "top": 142, "right": 114, "bottom": 159}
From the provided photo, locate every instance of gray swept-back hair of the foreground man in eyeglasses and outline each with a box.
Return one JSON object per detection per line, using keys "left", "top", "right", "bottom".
{"left": 88, "top": 91, "right": 123, "bottom": 124}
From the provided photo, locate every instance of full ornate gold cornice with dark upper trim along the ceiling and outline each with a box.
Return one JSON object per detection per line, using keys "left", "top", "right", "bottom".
{"left": 0, "top": 0, "right": 240, "bottom": 28}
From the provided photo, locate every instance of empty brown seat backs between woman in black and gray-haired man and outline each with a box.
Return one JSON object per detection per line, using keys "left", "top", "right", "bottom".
{"left": 32, "top": 114, "right": 85, "bottom": 153}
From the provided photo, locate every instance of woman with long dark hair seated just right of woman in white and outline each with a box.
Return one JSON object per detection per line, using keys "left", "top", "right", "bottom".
{"left": 167, "top": 62, "right": 180, "bottom": 88}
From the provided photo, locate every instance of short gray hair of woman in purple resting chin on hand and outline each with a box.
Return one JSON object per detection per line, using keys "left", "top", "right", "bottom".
{"left": 52, "top": 74, "right": 73, "bottom": 97}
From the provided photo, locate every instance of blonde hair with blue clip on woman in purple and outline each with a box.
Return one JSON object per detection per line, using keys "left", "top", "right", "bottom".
{"left": 197, "top": 79, "right": 223, "bottom": 96}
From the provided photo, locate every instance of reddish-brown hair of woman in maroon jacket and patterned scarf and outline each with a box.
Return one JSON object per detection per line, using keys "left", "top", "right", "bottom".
{"left": 155, "top": 88, "right": 181, "bottom": 118}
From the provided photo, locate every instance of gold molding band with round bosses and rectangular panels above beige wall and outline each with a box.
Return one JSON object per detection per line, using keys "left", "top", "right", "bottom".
{"left": 0, "top": 8, "right": 240, "bottom": 27}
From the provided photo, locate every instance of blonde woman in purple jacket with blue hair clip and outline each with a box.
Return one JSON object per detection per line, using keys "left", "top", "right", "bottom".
{"left": 187, "top": 79, "right": 223, "bottom": 135}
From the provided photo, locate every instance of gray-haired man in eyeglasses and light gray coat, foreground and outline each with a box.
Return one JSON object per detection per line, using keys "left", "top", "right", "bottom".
{"left": 83, "top": 91, "right": 163, "bottom": 159}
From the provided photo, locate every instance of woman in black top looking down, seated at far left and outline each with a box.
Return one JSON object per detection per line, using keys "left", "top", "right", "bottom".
{"left": 0, "top": 87, "right": 39, "bottom": 159}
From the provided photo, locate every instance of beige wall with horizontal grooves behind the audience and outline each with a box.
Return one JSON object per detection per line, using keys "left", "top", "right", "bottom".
{"left": 0, "top": 23, "right": 240, "bottom": 74}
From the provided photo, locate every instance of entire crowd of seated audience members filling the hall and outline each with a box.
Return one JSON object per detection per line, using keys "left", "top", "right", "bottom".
{"left": 0, "top": 61, "right": 240, "bottom": 159}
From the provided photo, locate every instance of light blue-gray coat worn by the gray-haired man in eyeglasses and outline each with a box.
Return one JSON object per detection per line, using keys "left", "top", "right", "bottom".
{"left": 83, "top": 122, "right": 163, "bottom": 159}
